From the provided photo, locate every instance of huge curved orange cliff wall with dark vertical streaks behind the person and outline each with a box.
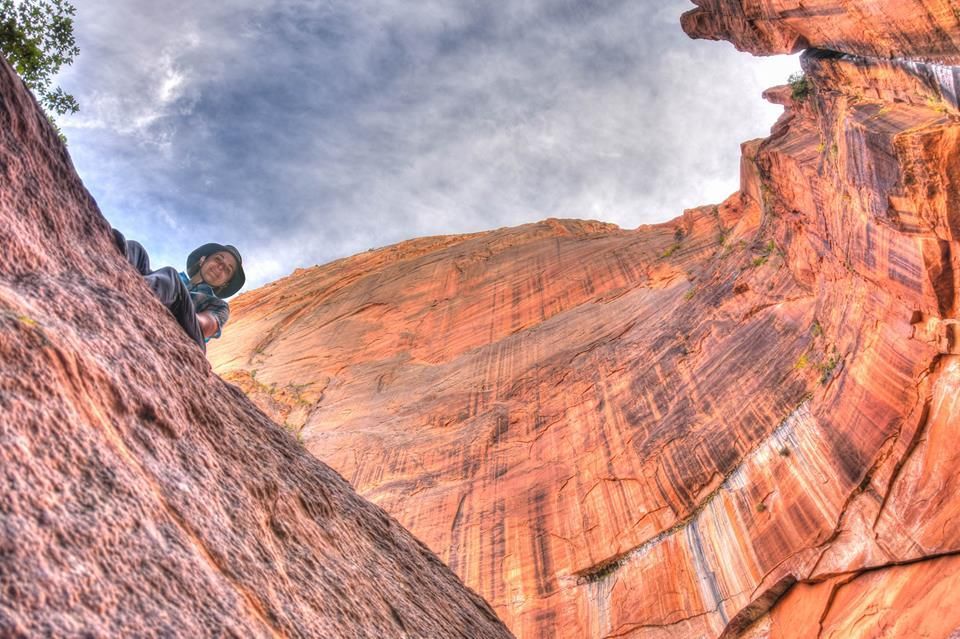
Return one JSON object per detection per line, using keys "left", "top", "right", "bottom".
{"left": 211, "top": 2, "right": 960, "bottom": 639}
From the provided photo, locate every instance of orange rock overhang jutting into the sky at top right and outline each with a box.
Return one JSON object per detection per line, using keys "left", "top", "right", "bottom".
{"left": 682, "top": 0, "right": 960, "bottom": 64}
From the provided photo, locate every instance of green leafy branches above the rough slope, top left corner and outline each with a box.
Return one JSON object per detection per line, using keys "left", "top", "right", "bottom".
{"left": 0, "top": 0, "right": 80, "bottom": 115}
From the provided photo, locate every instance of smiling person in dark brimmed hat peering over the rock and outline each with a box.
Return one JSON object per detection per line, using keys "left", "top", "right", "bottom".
{"left": 113, "top": 229, "right": 246, "bottom": 352}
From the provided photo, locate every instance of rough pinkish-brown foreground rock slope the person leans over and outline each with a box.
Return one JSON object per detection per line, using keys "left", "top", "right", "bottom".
{"left": 0, "top": 61, "right": 509, "bottom": 639}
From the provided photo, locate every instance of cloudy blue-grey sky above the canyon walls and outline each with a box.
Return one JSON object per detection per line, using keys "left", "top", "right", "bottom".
{"left": 58, "top": 0, "right": 799, "bottom": 290}
